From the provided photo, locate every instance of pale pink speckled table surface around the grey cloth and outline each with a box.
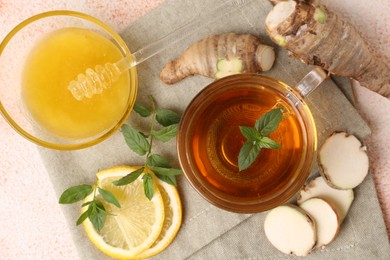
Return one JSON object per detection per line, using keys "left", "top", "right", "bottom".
{"left": 0, "top": 0, "right": 390, "bottom": 259}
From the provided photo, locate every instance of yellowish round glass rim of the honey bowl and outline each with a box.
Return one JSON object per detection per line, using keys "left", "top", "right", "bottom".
{"left": 0, "top": 10, "right": 138, "bottom": 150}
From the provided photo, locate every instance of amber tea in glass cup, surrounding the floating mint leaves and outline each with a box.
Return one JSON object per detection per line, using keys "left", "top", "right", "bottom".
{"left": 178, "top": 74, "right": 316, "bottom": 213}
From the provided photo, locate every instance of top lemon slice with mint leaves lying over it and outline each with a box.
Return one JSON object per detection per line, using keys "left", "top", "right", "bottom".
{"left": 83, "top": 166, "right": 165, "bottom": 258}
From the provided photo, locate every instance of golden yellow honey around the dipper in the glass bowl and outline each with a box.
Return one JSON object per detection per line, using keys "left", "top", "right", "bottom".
{"left": 22, "top": 27, "right": 130, "bottom": 139}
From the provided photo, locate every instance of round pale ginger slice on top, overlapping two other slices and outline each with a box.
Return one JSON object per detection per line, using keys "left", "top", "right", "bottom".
{"left": 264, "top": 204, "right": 316, "bottom": 256}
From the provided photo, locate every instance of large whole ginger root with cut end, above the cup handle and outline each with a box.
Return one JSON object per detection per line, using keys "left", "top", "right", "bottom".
{"left": 266, "top": 1, "right": 390, "bottom": 98}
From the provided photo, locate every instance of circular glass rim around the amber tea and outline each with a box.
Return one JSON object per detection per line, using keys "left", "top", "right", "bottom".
{"left": 176, "top": 73, "right": 317, "bottom": 213}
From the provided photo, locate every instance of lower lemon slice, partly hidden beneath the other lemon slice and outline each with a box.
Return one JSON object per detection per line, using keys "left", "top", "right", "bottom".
{"left": 137, "top": 177, "right": 182, "bottom": 258}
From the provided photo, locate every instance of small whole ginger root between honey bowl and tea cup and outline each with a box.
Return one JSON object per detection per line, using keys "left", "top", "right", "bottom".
{"left": 160, "top": 33, "right": 275, "bottom": 84}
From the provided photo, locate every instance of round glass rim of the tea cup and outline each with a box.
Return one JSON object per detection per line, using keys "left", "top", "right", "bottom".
{"left": 176, "top": 73, "right": 318, "bottom": 214}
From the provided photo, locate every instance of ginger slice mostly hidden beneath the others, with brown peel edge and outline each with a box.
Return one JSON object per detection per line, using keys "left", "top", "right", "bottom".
{"left": 297, "top": 176, "right": 354, "bottom": 222}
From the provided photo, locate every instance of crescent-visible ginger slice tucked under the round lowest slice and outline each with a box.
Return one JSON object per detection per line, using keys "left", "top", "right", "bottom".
{"left": 300, "top": 198, "right": 340, "bottom": 248}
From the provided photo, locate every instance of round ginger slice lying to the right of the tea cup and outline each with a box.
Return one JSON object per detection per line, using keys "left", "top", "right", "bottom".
{"left": 318, "top": 132, "right": 369, "bottom": 189}
